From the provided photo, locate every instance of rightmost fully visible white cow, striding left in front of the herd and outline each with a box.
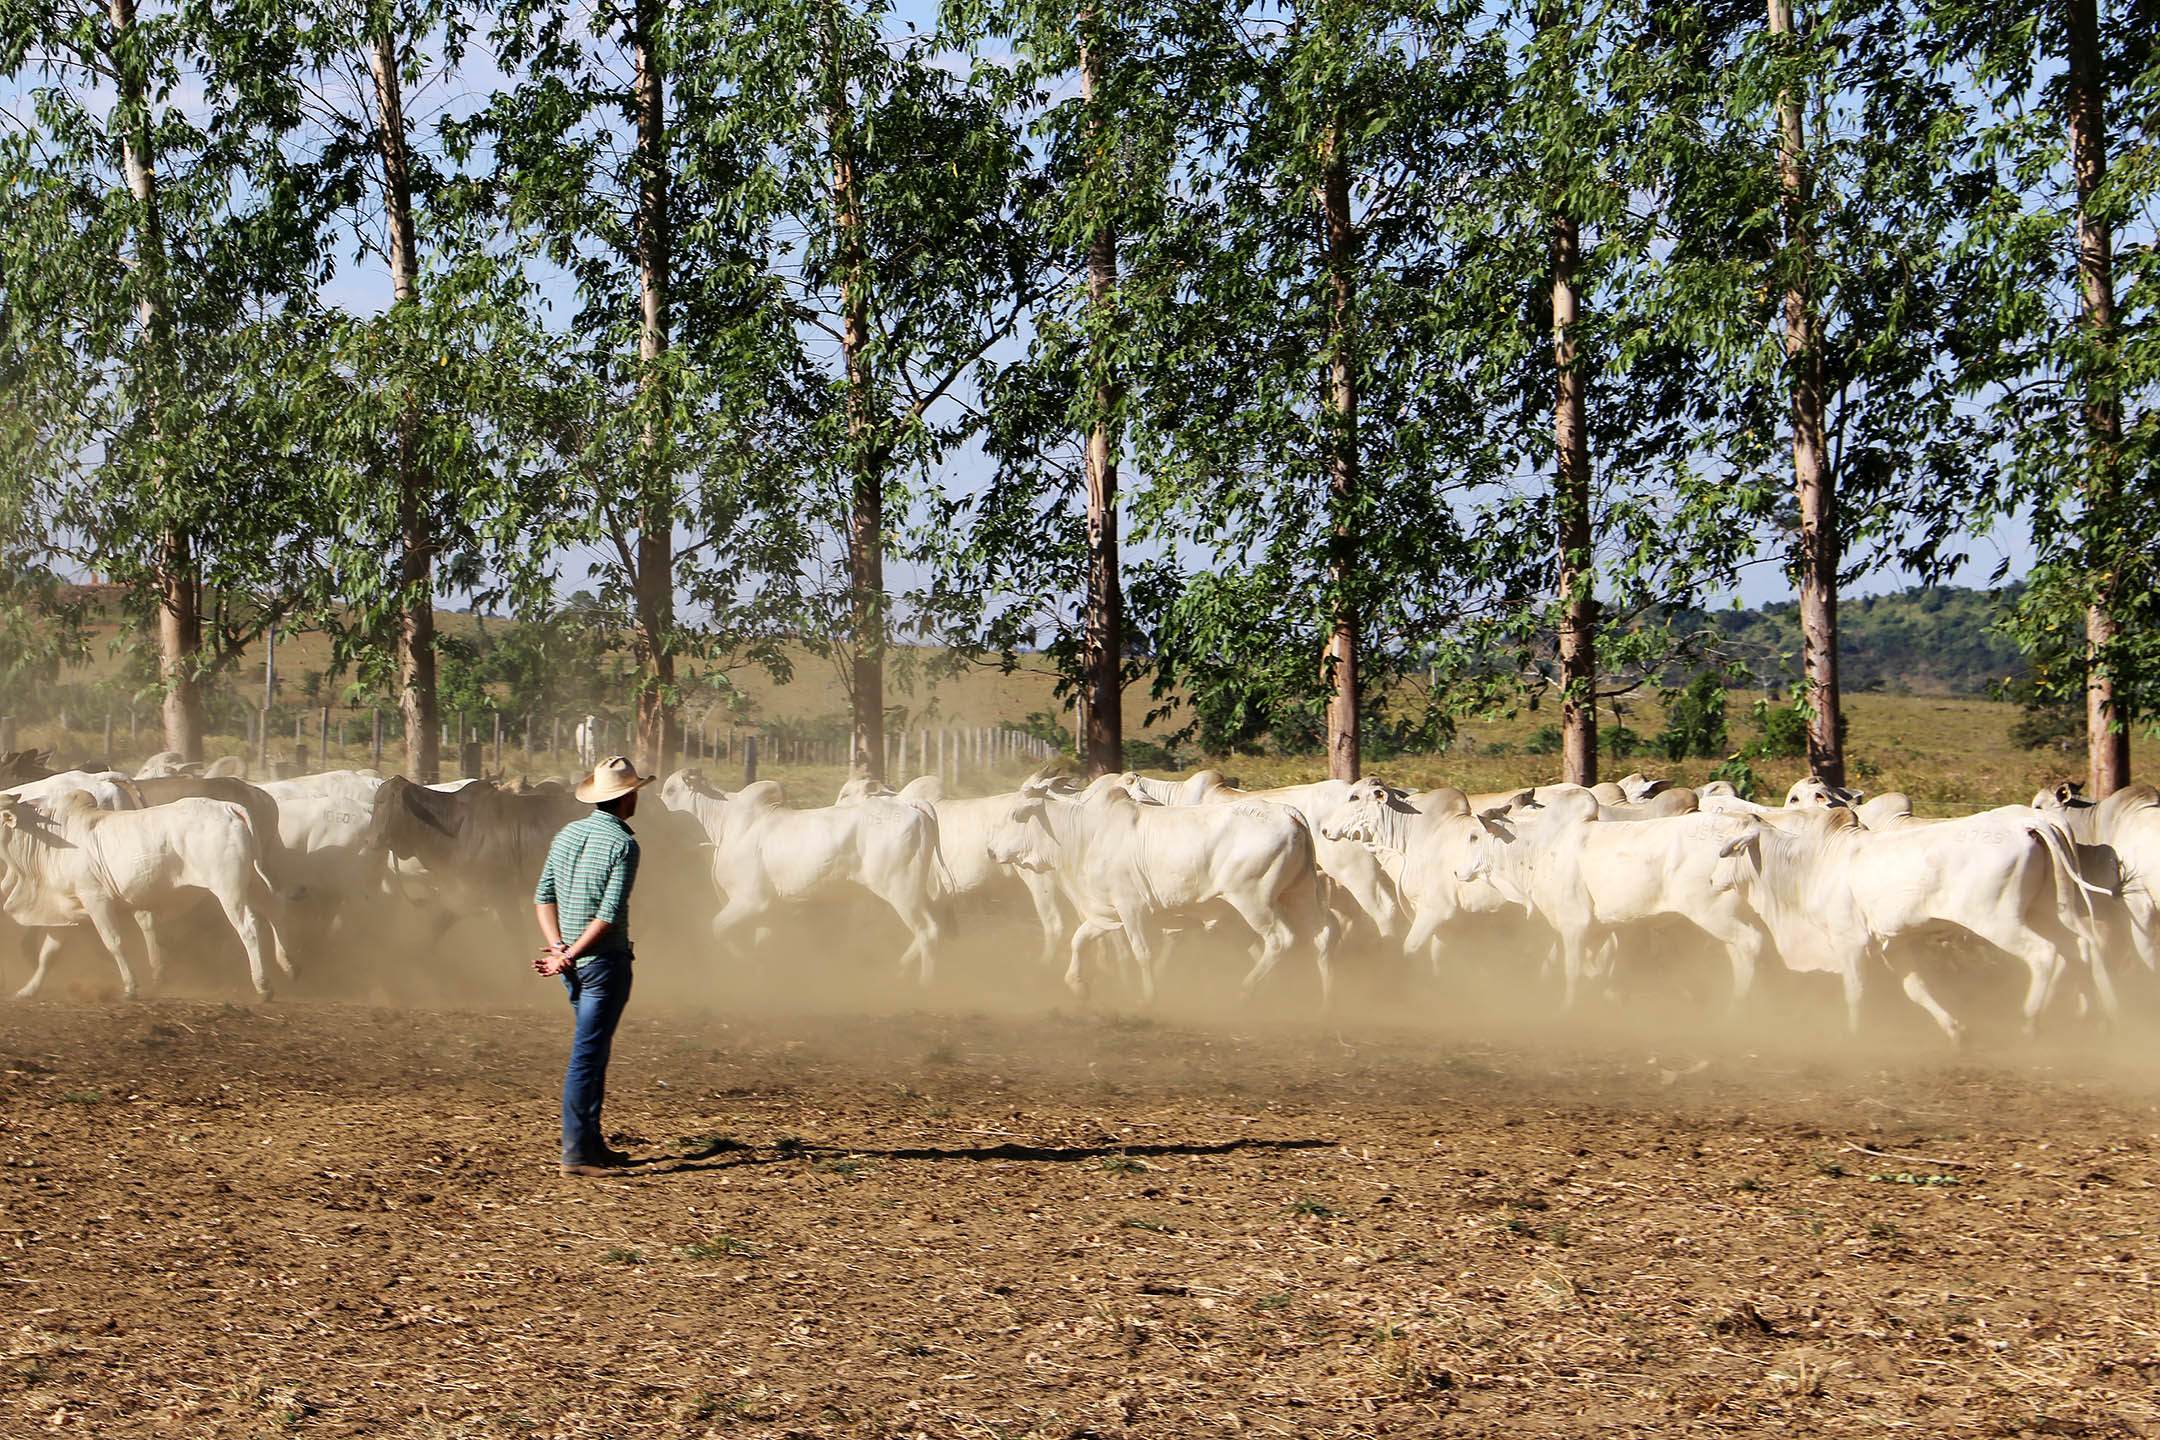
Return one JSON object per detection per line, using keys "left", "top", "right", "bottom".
{"left": 1724, "top": 807, "right": 2106, "bottom": 1043}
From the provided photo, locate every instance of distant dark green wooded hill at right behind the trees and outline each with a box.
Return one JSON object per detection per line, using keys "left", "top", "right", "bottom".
{"left": 1689, "top": 585, "right": 2026, "bottom": 695}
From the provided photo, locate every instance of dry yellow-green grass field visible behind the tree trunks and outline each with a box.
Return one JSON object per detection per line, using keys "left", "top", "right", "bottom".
{"left": 17, "top": 611, "right": 2151, "bottom": 814}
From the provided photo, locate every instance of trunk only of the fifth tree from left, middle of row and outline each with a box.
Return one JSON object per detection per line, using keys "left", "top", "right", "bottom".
{"left": 1080, "top": 6, "right": 1125, "bottom": 775}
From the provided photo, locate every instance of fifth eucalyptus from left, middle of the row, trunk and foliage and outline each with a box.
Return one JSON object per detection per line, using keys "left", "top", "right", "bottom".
{"left": 929, "top": 0, "right": 1175, "bottom": 773}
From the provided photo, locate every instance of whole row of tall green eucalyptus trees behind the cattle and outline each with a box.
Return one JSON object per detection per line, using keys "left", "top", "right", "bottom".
{"left": 0, "top": 0, "right": 2160, "bottom": 790}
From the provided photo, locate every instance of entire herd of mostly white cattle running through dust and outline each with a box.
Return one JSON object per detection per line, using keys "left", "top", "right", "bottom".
{"left": 0, "top": 756, "right": 2160, "bottom": 1041}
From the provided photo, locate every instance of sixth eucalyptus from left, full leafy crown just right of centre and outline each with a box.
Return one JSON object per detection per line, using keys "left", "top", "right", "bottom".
{"left": 1105, "top": 0, "right": 1529, "bottom": 777}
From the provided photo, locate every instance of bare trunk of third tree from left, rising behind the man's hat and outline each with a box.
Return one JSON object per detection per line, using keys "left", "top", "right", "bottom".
{"left": 631, "top": 0, "right": 676, "bottom": 775}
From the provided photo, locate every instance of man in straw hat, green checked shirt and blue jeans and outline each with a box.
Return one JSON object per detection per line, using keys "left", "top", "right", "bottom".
{"left": 534, "top": 756, "right": 652, "bottom": 1174}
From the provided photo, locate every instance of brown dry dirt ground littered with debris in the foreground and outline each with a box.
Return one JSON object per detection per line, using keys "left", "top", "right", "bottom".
{"left": 0, "top": 954, "right": 2160, "bottom": 1438}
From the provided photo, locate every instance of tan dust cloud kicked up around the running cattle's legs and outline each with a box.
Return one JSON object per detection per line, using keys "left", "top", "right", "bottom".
{"left": 16, "top": 833, "right": 2160, "bottom": 1086}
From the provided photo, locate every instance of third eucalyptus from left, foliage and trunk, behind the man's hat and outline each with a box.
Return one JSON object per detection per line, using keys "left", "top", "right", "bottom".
{"left": 462, "top": 0, "right": 812, "bottom": 769}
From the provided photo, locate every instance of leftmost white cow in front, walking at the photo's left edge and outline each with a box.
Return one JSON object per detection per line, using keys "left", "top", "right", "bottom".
{"left": 0, "top": 790, "right": 292, "bottom": 1000}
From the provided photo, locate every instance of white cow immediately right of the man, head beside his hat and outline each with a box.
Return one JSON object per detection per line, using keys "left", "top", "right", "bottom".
{"left": 661, "top": 769, "right": 950, "bottom": 984}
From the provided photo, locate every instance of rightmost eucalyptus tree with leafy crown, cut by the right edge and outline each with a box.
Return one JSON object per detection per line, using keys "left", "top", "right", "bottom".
{"left": 1927, "top": 0, "right": 2160, "bottom": 794}
